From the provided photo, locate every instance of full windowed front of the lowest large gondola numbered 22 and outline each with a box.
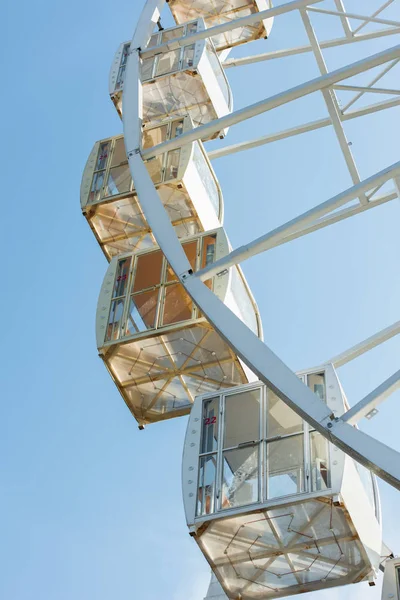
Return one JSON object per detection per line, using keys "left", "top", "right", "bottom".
{"left": 197, "top": 373, "right": 330, "bottom": 516}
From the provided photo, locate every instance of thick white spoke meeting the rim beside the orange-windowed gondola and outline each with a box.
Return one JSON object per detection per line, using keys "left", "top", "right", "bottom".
{"left": 194, "top": 161, "right": 400, "bottom": 281}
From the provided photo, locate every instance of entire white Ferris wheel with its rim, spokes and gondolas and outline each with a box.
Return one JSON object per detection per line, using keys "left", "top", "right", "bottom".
{"left": 81, "top": 0, "right": 400, "bottom": 600}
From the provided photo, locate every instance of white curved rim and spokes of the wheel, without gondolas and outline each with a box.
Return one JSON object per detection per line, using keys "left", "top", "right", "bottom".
{"left": 123, "top": 0, "right": 400, "bottom": 489}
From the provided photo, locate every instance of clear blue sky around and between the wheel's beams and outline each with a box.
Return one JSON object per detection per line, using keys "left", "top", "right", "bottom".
{"left": 0, "top": 0, "right": 400, "bottom": 600}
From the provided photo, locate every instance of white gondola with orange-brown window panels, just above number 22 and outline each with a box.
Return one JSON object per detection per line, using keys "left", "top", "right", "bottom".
{"left": 96, "top": 228, "right": 262, "bottom": 425}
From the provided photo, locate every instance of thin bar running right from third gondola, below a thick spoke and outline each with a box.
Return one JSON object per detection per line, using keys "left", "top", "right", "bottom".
{"left": 208, "top": 98, "right": 400, "bottom": 160}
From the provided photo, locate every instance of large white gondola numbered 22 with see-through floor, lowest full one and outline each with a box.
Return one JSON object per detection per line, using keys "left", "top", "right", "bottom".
{"left": 182, "top": 365, "right": 382, "bottom": 600}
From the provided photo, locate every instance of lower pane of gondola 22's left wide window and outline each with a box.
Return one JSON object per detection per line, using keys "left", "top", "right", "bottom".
{"left": 221, "top": 444, "right": 259, "bottom": 508}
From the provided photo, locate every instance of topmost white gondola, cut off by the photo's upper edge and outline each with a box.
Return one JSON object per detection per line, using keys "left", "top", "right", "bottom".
{"left": 169, "top": 0, "right": 273, "bottom": 51}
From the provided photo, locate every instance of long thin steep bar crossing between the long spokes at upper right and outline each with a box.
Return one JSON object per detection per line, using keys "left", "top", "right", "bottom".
{"left": 300, "top": 10, "right": 368, "bottom": 204}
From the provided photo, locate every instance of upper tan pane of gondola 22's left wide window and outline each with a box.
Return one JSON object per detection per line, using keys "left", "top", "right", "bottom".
{"left": 223, "top": 389, "right": 260, "bottom": 448}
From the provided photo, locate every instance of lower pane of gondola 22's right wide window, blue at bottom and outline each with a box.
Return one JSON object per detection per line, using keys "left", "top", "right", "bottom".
{"left": 267, "top": 435, "right": 304, "bottom": 498}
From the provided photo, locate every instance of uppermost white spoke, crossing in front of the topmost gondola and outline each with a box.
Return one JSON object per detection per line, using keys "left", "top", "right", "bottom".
{"left": 140, "top": 0, "right": 322, "bottom": 58}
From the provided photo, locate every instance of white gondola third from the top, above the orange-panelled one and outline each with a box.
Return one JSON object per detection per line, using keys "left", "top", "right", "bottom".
{"left": 81, "top": 117, "right": 223, "bottom": 260}
